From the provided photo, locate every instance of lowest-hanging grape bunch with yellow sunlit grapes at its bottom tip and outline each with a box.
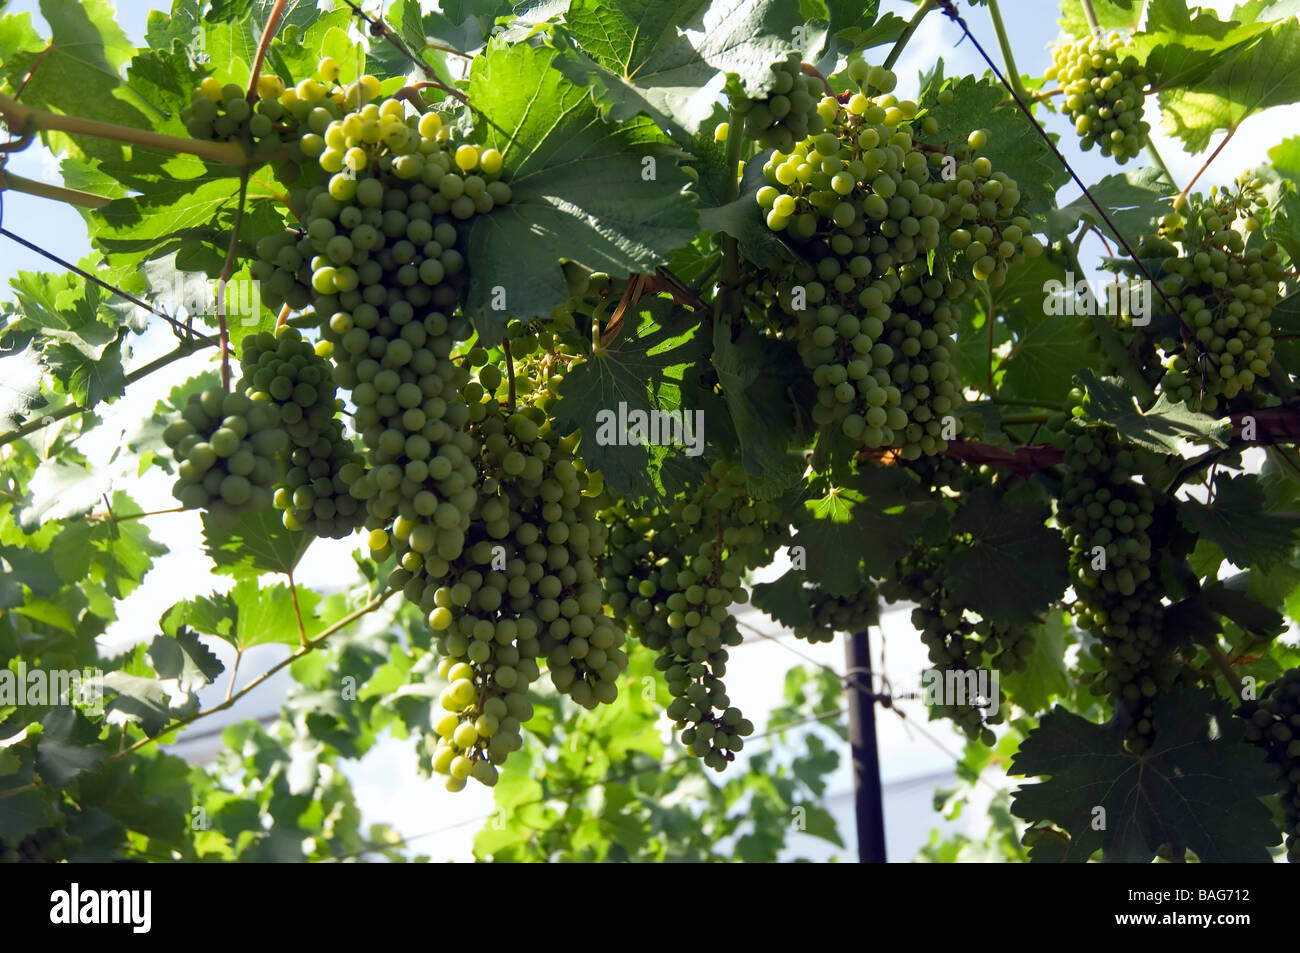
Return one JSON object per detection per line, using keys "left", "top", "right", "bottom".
{"left": 403, "top": 367, "right": 628, "bottom": 790}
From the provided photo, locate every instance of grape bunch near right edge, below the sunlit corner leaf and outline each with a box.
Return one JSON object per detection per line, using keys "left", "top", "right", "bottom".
{"left": 1156, "top": 179, "right": 1284, "bottom": 411}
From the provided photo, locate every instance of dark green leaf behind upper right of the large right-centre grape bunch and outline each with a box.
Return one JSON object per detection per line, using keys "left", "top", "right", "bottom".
{"left": 915, "top": 77, "right": 1070, "bottom": 217}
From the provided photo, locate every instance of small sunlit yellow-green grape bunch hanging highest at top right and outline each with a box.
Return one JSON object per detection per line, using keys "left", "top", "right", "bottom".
{"left": 1047, "top": 34, "right": 1151, "bottom": 165}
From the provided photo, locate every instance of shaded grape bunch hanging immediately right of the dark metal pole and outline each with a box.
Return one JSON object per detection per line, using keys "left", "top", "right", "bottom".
{"left": 881, "top": 540, "right": 1034, "bottom": 745}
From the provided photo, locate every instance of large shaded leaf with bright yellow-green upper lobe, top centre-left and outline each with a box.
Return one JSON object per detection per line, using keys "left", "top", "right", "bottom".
{"left": 467, "top": 44, "right": 698, "bottom": 323}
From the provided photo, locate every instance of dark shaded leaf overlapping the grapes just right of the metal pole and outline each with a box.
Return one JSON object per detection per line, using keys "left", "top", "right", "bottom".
{"left": 946, "top": 489, "right": 1070, "bottom": 625}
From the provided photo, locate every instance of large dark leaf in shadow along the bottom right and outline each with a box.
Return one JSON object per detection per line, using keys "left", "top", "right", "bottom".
{"left": 1009, "top": 688, "right": 1278, "bottom": 863}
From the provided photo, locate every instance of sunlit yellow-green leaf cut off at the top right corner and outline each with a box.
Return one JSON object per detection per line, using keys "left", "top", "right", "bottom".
{"left": 1160, "top": 14, "right": 1300, "bottom": 152}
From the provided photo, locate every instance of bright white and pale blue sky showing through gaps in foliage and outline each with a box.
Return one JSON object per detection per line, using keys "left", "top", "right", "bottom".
{"left": 0, "top": 0, "right": 1300, "bottom": 859}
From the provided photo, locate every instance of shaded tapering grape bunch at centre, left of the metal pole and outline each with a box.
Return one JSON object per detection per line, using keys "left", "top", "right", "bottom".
{"left": 605, "top": 462, "right": 784, "bottom": 771}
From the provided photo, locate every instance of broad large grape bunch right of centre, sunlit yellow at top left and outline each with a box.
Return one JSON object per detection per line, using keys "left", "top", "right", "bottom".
{"left": 757, "top": 64, "right": 1043, "bottom": 459}
